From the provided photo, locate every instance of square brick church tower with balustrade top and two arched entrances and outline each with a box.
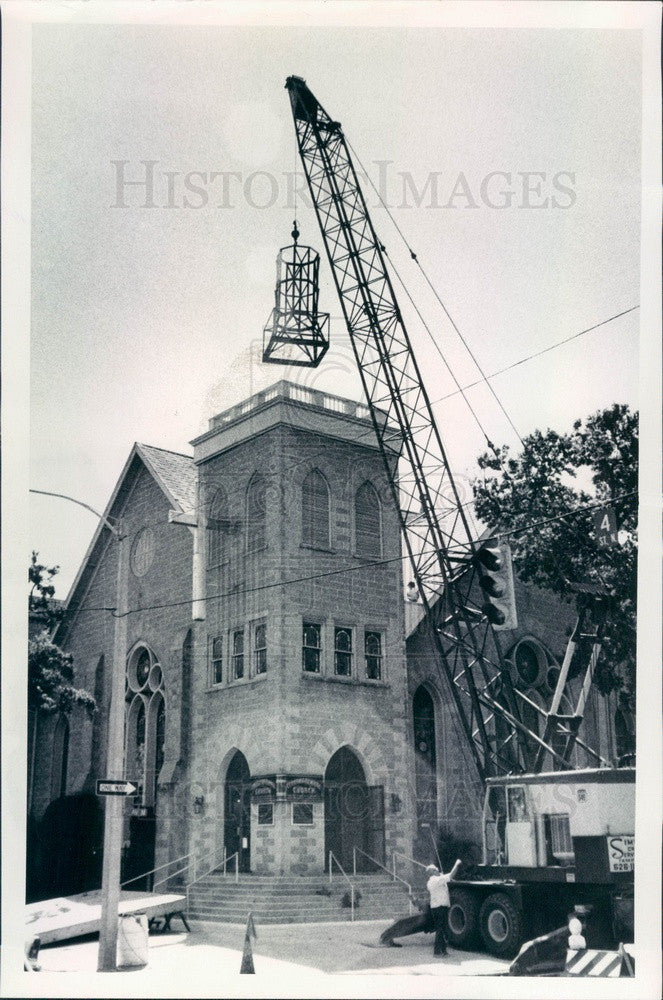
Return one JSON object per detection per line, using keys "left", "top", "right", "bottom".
{"left": 189, "top": 381, "right": 414, "bottom": 875}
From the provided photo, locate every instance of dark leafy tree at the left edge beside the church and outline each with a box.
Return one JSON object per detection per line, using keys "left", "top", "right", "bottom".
{"left": 28, "top": 552, "right": 95, "bottom": 715}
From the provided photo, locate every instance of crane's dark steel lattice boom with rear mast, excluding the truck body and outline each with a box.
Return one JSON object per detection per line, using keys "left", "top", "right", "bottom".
{"left": 285, "top": 76, "right": 607, "bottom": 783}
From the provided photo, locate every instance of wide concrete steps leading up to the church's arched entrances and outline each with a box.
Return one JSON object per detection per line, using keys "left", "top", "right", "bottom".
{"left": 189, "top": 872, "right": 408, "bottom": 924}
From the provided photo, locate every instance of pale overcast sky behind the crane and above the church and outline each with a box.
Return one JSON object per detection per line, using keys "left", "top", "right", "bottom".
{"left": 30, "top": 17, "right": 641, "bottom": 597}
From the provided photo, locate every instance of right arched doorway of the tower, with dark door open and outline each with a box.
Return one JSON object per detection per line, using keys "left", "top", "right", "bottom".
{"left": 325, "top": 746, "right": 384, "bottom": 872}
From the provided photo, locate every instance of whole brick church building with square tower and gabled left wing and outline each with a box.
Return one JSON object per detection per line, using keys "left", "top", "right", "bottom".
{"left": 29, "top": 382, "right": 628, "bottom": 877}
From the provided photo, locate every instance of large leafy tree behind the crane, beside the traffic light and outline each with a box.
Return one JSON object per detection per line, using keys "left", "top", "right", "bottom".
{"left": 473, "top": 403, "right": 638, "bottom": 693}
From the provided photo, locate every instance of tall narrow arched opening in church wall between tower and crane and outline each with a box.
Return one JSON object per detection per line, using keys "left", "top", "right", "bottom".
{"left": 412, "top": 684, "right": 437, "bottom": 858}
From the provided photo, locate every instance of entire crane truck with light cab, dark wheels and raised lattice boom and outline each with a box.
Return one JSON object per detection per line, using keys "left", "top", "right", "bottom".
{"left": 276, "top": 76, "right": 635, "bottom": 955}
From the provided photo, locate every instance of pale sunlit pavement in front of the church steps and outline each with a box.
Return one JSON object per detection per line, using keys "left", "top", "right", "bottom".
{"left": 39, "top": 921, "right": 508, "bottom": 976}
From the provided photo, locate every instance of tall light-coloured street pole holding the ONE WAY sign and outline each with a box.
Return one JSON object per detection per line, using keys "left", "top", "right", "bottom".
{"left": 97, "top": 518, "right": 128, "bottom": 972}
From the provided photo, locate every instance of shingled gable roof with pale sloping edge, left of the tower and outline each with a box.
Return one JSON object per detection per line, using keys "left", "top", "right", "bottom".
{"left": 56, "top": 443, "right": 198, "bottom": 639}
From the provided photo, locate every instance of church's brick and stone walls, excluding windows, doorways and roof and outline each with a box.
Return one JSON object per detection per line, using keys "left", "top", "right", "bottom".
{"left": 32, "top": 386, "right": 614, "bottom": 875}
